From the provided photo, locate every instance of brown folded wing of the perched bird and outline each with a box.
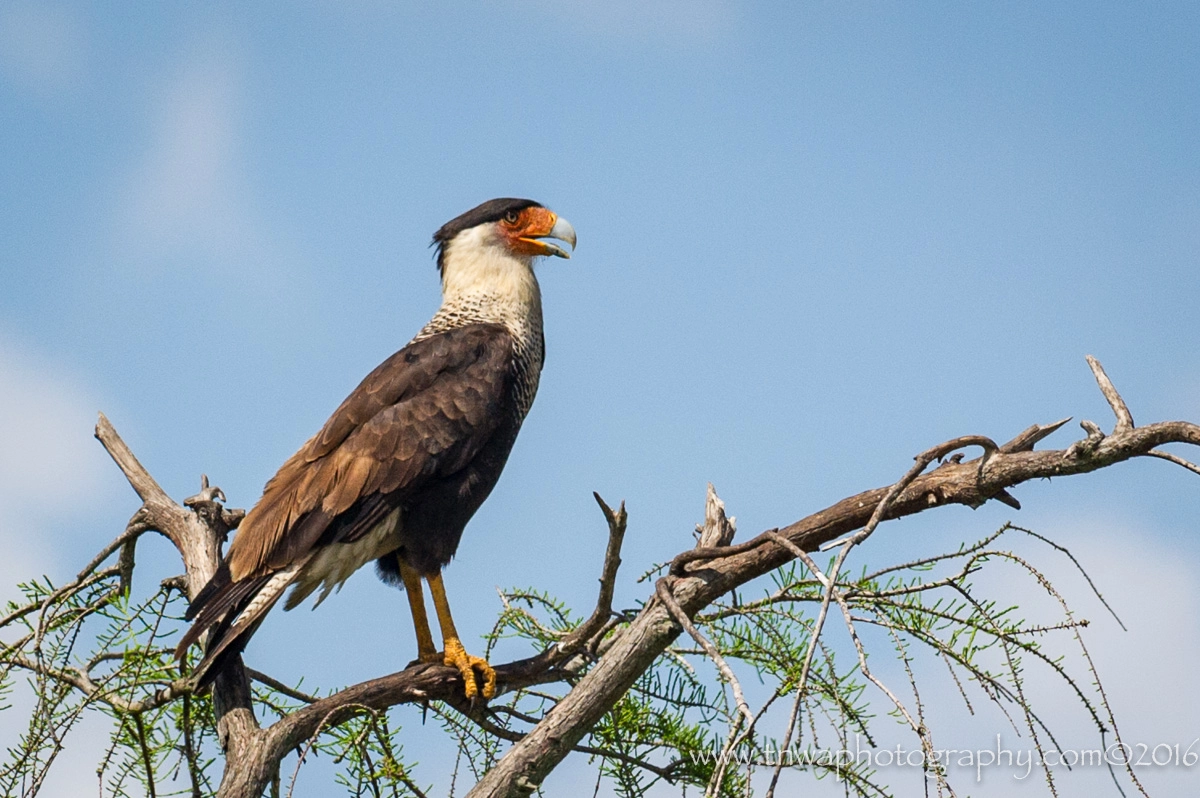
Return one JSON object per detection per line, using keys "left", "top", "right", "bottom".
{"left": 228, "top": 324, "right": 512, "bottom": 582}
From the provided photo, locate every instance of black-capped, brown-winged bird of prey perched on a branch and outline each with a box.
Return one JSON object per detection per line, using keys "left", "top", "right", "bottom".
{"left": 175, "top": 198, "right": 576, "bottom": 700}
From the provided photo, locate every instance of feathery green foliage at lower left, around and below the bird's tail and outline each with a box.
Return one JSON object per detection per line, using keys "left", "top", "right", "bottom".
{"left": 0, "top": 554, "right": 424, "bottom": 798}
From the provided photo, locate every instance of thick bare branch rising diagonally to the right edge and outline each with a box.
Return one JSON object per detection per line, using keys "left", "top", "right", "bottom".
{"left": 468, "top": 359, "right": 1200, "bottom": 798}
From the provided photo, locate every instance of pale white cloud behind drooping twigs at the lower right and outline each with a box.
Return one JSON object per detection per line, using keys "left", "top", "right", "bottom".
{"left": 902, "top": 518, "right": 1200, "bottom": 798}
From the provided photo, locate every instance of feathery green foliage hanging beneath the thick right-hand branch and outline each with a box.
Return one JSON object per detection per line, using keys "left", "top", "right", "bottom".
{"left": 482, "top": 526, "right": 1133, "bottom": 798}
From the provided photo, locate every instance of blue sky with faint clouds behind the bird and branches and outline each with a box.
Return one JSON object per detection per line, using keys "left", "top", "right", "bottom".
{"left": 0, "top": 0, "right": 1200, "bottom": 794}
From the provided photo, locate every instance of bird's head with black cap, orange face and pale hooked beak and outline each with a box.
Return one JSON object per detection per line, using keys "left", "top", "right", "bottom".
{"left": 433, "top": 198, "right": 575, "bottom": 289}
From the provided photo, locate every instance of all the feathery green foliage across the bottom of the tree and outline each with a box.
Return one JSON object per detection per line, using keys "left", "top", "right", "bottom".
{"left": 0, "top": 527, "right": 1135, "bottom": 798}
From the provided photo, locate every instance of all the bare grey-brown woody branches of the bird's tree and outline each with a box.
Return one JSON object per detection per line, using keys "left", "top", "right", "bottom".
{"left": 72, "top": 358, "right": 1200, "bottom": 798}
